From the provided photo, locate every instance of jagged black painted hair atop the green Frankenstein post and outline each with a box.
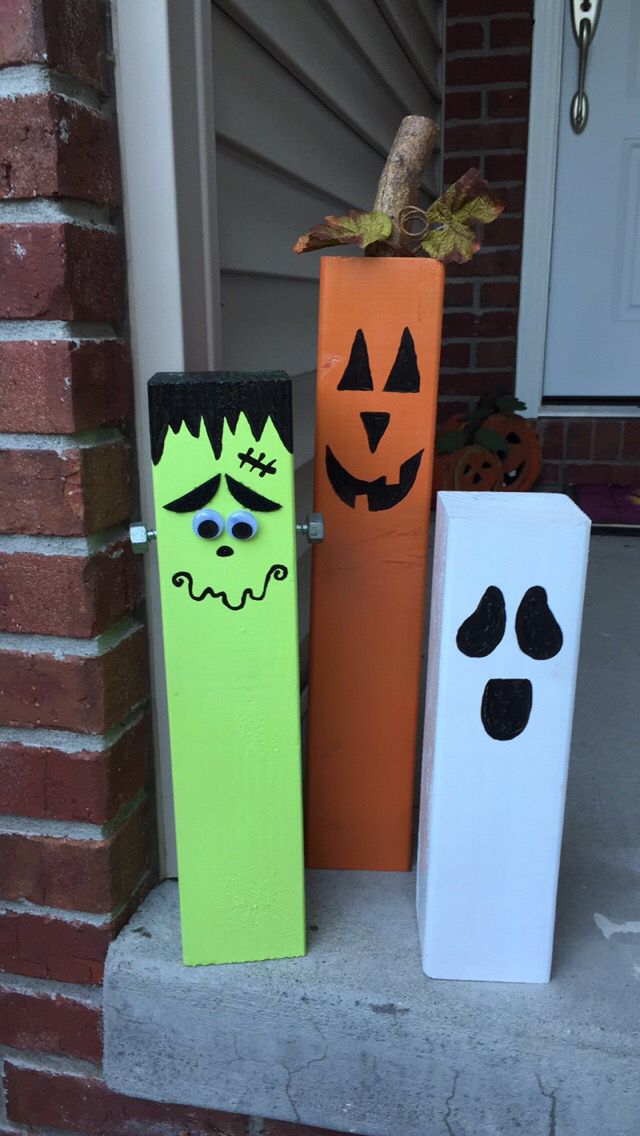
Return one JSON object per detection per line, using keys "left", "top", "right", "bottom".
{"left": 149, "top": 370, "right": 293, "bottom": 466}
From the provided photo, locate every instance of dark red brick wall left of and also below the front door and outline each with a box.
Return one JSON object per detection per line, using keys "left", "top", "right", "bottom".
{"left": 440, "top": 0, "right": 640, "bottom": 490}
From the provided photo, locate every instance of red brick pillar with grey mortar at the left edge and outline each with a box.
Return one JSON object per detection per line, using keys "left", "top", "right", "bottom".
{"left": 0, "top": 0, "right": 151, "bottom": 1131}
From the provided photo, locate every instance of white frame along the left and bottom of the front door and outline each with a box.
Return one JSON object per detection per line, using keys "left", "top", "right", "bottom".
{"left": 516, "top": 0, "right": 640, "bottom": 418}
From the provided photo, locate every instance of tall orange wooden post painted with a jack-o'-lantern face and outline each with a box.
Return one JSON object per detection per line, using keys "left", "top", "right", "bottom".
{"left": 306, "top": 257, "right": 444, "bottom": 870}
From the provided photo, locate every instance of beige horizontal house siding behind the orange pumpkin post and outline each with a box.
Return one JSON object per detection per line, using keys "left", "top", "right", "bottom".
{"left": 211, "top": 0, "right": 441, "bottom": 663}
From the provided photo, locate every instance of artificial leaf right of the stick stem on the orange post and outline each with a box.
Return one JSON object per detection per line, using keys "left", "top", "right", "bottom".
{"left": 419, "top": 169, "right": 505, "bottom": 265}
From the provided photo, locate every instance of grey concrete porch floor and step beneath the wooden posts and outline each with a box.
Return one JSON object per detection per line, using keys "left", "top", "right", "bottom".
{"left": 105, "top": 536, "right": 640, "bottom": 1136}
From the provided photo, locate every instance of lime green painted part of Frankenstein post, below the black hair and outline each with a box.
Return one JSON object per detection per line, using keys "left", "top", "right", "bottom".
{"left": 153, "top": 415, "right": 305, "bottom": 964}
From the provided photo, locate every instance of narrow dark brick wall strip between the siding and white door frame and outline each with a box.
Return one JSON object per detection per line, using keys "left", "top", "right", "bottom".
{"left": 440, "top": 0, "right": 532, "bottom": 427}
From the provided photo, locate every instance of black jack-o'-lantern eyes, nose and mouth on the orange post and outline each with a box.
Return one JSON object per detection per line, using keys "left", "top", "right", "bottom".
{"left": 325, "top": 327, "right": 424, "bottom": 512}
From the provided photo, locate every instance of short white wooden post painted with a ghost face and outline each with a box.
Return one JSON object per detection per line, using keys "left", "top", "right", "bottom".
{"left": 417, "top": 493, "right": 589, "bottom": 983}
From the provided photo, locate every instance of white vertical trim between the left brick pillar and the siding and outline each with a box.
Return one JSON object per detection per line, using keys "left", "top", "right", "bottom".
{"left": 113, "top": 0, "right": 221, "bottom": 876}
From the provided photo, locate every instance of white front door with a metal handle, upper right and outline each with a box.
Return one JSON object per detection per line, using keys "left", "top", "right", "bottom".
{"left": 543, "top": 0, "right": 640, "bottom": 402}
